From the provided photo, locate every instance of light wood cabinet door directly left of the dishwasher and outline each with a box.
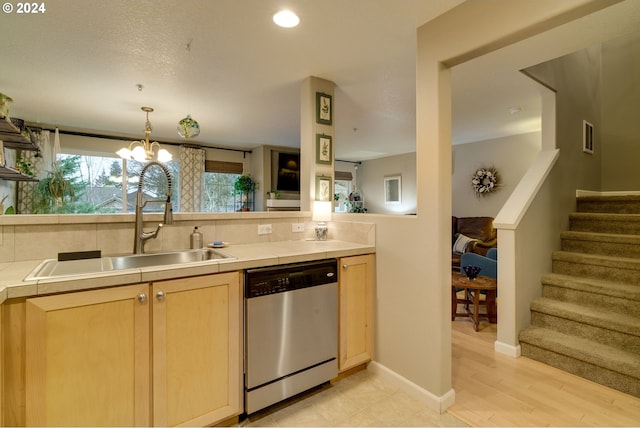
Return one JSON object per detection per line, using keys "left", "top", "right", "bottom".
{"left": 152, "top": 272, "right": 242, "bottom": 426}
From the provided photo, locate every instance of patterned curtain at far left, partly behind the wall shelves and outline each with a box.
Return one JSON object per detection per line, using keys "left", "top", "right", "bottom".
{"left": 16, "top": 131, "right": 50, "bottom": 214}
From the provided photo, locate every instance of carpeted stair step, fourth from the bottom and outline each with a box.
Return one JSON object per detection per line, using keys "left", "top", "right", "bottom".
{"left": 551, "top": 251, "right": 640, "bottom": 285}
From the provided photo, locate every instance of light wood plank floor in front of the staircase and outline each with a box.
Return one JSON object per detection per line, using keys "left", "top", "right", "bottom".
{"left": 449, "top": 319, "right": 640, "bottom": 427}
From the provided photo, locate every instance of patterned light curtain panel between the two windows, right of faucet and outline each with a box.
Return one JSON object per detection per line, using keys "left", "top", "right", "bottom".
{"left": 180, "top": 146, "right": 205, "bottom": 212}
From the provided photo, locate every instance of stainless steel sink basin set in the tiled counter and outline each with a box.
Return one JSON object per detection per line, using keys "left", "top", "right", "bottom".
{"left": 25, "top": 248, "right": 236, "bottom": 281}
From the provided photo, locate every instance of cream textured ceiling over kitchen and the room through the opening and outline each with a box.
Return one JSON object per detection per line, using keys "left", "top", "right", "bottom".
{"left": 0, "top": 0, "right": 636, "bottom": 161}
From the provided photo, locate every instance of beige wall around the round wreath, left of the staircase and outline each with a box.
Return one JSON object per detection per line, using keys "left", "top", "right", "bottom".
{"left": 451, "top": 132, "right": 541, "bottom": 217}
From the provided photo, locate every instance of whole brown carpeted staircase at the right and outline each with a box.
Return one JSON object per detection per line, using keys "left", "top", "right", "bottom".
{"left": 520, "top": 196, "right": 640, "bottom": 397}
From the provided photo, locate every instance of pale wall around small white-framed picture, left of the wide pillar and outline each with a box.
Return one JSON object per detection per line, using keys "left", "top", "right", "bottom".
{"left": 357, "top": 153, "right": 417, "bottom": 214}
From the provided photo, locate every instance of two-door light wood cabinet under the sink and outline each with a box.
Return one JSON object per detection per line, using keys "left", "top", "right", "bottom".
{"left": 25, "top": 272, "right": 242, "bottom": 426}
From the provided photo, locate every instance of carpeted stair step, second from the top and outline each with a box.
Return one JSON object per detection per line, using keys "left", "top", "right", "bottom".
{"left": 569, "top": 212, "right": 640, "bottom": 235}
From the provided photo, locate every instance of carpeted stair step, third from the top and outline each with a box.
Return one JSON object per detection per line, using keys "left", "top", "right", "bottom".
{"left": 560, "top": 231, "right": 640, "bottom": 258}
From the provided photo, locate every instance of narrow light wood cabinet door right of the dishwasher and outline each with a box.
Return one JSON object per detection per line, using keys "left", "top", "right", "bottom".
{"left": 338, "top": 254, "right": 375, "bottom": 372}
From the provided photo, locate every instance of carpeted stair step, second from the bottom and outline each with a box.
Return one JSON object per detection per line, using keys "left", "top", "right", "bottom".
{"left": 531, "top": 297, "right": 640, "bottom": 356}
